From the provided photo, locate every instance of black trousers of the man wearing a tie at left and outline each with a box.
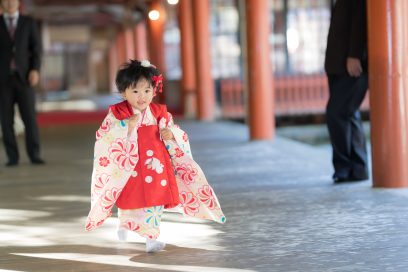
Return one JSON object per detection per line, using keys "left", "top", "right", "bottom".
{"left": 0, "top": 74, "right": 40, "bottom": 162}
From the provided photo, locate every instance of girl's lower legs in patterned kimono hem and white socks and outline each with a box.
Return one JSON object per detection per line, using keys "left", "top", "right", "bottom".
{"left": 118, "top": 206, "right": 166, "bottom": 252}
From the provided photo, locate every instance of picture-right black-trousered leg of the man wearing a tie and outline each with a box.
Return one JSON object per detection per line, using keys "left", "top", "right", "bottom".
{"left": 16, "top": 79, "right": 42, "bottom": 163}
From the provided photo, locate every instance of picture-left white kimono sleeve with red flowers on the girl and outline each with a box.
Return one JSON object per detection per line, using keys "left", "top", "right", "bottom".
{"left": 86, "top": 112, "right": 138, "bottom": 231}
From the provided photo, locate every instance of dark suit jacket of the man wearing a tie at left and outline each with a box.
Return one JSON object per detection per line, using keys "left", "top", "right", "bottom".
{"left": 0, "top": 14, "right": 41, "bottom": 82}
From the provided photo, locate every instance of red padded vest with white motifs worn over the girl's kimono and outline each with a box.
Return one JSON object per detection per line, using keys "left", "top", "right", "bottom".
{"left": 111, "top": 101, "right": 180, "bottom": 209}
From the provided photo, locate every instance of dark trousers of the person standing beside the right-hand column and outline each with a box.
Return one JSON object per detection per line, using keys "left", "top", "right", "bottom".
{"left": 326, "top": 73, "right": 368, "bottom": 178}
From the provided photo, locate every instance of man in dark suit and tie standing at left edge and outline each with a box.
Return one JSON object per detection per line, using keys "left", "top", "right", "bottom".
{"left": 0, "top": 0, "right": 44, "bottom": 166}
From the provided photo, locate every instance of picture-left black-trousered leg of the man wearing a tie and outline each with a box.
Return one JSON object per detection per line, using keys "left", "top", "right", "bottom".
{"left": 0, "top": 77, "right": 19, "bottom": 166}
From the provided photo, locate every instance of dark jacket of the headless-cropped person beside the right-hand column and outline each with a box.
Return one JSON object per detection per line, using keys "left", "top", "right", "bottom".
{"left": 324, "top": 0, "right": 367, "bottom": 74}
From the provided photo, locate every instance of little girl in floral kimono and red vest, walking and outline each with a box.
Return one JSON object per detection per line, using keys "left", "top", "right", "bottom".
{"left": 86, "top": 60, "right": 225, "bottom": 252}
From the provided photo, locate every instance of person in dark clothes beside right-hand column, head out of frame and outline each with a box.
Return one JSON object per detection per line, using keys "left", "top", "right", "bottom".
{"left": 325, "top": 0, "right": 368, "bottom": 183}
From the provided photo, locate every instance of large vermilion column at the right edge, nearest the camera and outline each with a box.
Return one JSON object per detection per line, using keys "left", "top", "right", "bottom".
{"left": 367, "top": 0, "right": 408, "bottom": 187}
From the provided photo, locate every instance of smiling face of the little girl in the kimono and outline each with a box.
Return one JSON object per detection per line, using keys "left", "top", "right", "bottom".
{"left": 122, "top": 78, "right": 154, "bottom": 111}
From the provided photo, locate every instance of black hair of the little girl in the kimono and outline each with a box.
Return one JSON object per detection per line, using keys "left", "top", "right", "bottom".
{"left": 115, "top": 60, "right": 160, "bottom": 93}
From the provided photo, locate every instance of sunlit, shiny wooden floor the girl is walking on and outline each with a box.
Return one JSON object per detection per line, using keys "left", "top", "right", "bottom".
{"left": 0, "top": 121, "right": 408, "bottom": 272}
